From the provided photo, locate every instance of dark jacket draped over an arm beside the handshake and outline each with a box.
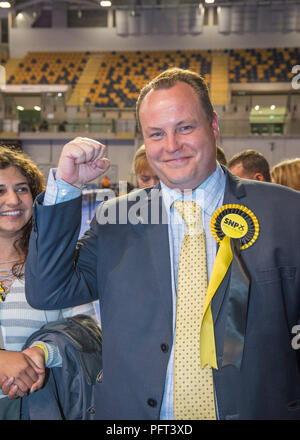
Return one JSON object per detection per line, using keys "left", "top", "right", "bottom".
{"left": 22, "top": 315, "right": 102, "bottom": 420}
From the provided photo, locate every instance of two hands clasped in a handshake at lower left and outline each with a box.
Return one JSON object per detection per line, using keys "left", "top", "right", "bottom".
{"left": 0, "top": 351, "right": 44, "bottom": 399}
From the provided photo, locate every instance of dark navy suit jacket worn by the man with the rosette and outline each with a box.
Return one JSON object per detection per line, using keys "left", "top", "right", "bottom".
{"left": 26, "top": 170, "right": 300, "bottom": 419}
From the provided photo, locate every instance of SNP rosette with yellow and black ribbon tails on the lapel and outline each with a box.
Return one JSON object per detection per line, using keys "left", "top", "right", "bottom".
{"left": 200, "top": 204, "right": 259, "bottom": 369}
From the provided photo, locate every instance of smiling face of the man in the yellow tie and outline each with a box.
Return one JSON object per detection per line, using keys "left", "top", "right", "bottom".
{"left": 139, "top": 82, "right": 219, "bottom": 191}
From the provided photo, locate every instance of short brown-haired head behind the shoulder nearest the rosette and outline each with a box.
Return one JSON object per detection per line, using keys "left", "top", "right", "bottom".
{"left": 227, "top": 149, "right": 271, "bottom": 182}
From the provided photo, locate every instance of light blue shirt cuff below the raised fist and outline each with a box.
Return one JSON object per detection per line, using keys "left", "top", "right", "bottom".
{"left": 44, "top": 168, "right": 81, "bottom": 206}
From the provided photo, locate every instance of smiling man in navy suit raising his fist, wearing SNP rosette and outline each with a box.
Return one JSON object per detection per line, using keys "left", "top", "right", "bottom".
{"left": 22, "top": 69, "right": 300, "bottom": 419}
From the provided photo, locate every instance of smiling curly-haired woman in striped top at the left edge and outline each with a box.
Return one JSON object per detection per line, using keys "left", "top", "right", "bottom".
{"left": 0, "top": 146, "right": 97, "bottom": 420}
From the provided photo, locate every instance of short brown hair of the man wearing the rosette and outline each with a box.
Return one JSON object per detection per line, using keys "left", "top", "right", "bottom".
{"left": 136, "top": 67, "right": 214, "bottom": 132}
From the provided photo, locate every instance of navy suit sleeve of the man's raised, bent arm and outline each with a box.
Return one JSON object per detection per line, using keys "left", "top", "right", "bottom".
{"left": 25, "top": 194, "right": 98, "bottom": 310}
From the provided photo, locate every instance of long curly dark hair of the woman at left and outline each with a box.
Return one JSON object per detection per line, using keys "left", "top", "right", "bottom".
{"left": 0, "top": 145, "right": 45, "bottom": 277}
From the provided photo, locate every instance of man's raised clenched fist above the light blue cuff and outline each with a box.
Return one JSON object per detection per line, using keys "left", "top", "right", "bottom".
{"left": 56, "top": 137, "right": 110, "bottom": 187}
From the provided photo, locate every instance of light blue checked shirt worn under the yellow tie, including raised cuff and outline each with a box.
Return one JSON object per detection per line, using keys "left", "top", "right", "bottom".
{"left": 44, "top": 163, "right": 226, "bottom": 420}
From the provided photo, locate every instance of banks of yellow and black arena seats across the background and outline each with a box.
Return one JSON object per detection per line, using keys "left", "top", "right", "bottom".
{"left": 0, "top": 48, "right": 300, "bottom": 108}
